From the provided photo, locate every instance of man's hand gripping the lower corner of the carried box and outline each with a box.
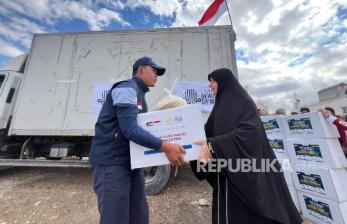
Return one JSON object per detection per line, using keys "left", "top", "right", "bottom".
{"left": 161, "top": 142, "right": 186, "bottom": 166}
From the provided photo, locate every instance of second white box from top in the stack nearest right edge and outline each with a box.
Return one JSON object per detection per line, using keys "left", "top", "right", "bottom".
{"left": 284, "top": 139, "right": 347, "bottom": 168}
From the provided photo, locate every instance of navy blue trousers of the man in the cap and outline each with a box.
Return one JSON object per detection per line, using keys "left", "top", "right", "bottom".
{"left": 92, "top": 165, "right": 149, "bottom": 224}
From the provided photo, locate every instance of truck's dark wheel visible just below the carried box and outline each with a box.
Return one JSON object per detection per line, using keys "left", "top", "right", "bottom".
{"left": 144, "top": 165, "right": 171, "bottom": 195}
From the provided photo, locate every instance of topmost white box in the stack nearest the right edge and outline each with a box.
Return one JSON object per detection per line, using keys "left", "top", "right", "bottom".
{"left": 281, "top": 112, "right": 340, "bottom": 139}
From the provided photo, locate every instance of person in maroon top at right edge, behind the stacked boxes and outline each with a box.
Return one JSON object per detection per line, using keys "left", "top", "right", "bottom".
{"left": 319, "top": 107, "right": 347, "bottom": 156}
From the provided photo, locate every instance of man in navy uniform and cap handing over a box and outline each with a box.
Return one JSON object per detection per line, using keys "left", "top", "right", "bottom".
{"left": 89, "top": 57, "right": 185, "bottom": 224}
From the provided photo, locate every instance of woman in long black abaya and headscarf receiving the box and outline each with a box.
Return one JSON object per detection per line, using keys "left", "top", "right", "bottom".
{"left": 191, "top": 68, "right": 302, "bottom": 224}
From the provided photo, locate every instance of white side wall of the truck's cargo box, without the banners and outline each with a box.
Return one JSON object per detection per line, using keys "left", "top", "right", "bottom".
{"left": 10, "top": 26, "right": 237, "bottom": 136}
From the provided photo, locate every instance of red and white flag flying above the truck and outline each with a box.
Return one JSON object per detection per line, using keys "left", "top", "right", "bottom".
{"left": 199, "top": 0, "right": 228, "bottom": 26}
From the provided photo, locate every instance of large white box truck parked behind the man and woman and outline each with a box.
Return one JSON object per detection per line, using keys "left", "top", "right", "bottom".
{"left": 0, "top": 26, "right": 237, "bottom": 194}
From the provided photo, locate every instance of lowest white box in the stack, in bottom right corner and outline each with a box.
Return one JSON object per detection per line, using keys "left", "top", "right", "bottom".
{"left": 297, "top": 191, "right": 347, "bottom": 224}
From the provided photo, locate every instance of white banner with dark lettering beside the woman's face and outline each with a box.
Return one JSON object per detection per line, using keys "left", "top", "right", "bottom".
{"left": 174, "top": 82, "right": 215, "bottom": 112}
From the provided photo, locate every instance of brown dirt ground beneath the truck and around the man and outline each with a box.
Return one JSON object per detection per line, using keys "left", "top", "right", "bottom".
{"left": 0, "top": 167, "right": 311, "bottom": 224}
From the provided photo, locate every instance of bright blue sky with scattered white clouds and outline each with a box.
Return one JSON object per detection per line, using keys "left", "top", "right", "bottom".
{"left": 0, "top": 0, "right": 347, "bottom": 112}
